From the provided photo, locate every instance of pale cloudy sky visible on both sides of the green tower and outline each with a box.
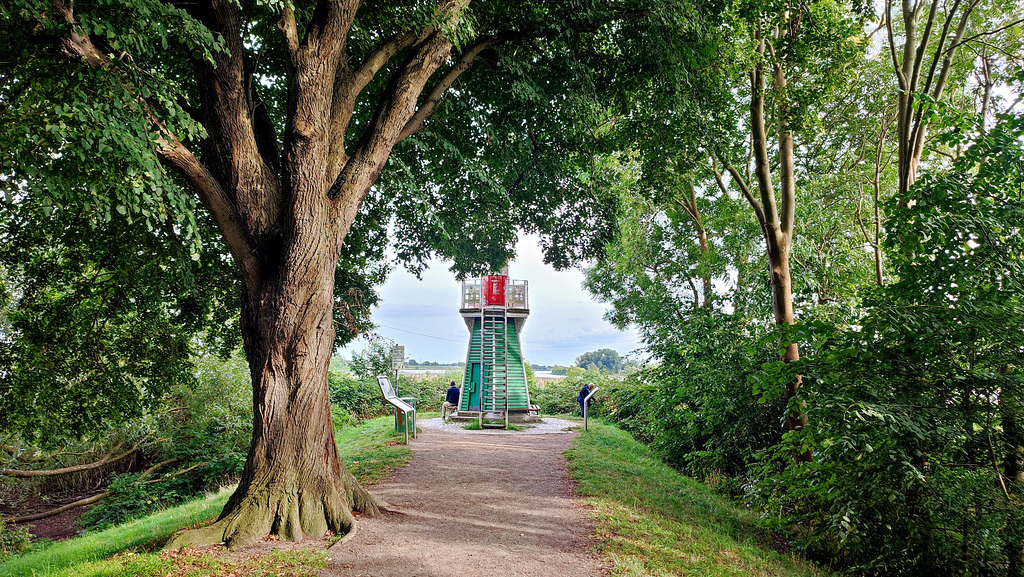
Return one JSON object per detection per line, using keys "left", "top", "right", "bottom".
{"left": 342, "top": 235, "right": 640, "bottom": 365}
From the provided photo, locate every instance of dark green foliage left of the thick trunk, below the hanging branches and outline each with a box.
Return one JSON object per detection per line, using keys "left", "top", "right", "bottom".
{"left": 0, "top": 208, "right": 238, "bottom": 444}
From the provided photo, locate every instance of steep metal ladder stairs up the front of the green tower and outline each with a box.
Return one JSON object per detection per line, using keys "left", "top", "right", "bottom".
{"left": 477, "top": 306, "right": 509, "bottom": 428}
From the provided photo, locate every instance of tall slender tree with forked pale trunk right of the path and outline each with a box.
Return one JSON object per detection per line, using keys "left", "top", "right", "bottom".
{"left": 721, "top": 2, "right": 858, "bottom": 460}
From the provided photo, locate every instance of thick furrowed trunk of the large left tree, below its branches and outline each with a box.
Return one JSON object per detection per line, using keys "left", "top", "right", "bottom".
{"left": 169, "top": 233, "right": 382, "bottom": 547}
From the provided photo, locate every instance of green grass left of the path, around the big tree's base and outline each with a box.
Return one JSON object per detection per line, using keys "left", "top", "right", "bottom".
{"left": 0, "top": 416, "right": 412, "bottom": 577}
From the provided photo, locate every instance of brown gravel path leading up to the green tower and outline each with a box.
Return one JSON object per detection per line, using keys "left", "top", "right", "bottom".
{"left": 322, "top": 419, "right": 602, "bottom": 577}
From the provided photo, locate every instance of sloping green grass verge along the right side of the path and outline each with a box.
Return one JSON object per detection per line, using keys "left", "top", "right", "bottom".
{"left": 566, "top": 420, "right": 823, "bottom": 577}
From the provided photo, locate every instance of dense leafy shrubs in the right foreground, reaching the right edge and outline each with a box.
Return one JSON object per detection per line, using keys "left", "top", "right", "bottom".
{"left": 750, "top": 118, "right": 1024, "bottom": 576}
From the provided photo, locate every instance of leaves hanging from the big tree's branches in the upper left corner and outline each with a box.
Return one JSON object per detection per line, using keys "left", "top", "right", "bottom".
{"left": 0, "top": 0, "right": 222, "bottom": 241}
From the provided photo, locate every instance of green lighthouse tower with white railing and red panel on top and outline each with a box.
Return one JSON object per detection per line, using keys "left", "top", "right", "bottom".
{"left": 459, "top": 267, "right": 537, "bottom": 427}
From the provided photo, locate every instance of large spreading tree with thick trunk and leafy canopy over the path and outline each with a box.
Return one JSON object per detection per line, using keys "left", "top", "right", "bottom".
{"left": 0, "top": 0, "right": 720, "bottom": 545}
